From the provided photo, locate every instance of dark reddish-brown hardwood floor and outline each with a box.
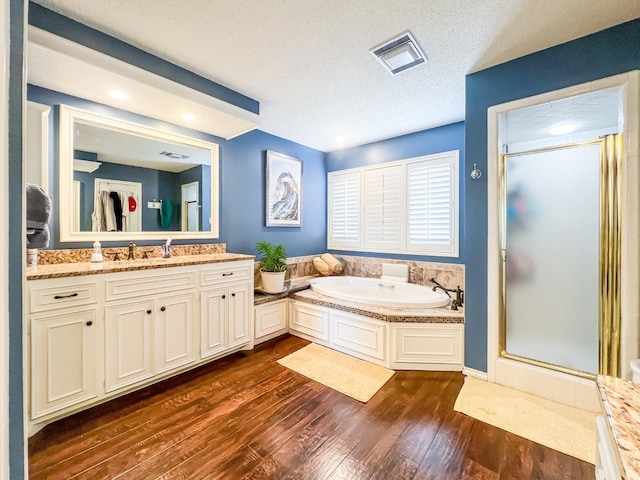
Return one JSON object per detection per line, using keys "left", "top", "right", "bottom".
{"left": 29, "top": 335, "right": 594, "bottom": 480}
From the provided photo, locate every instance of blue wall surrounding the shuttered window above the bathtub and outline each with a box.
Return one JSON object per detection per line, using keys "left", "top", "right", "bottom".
{"left": 326, "top": 122, "right": 466, "bottom": 263}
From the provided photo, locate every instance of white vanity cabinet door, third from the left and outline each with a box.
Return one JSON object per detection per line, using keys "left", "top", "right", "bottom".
{"left": 154, "top": 292, "right": 196, "bottom": 374}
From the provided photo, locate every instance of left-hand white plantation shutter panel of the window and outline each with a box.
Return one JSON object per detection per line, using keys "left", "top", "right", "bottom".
{"left": 327, "top": 171, "right": 362, "bottom": 248}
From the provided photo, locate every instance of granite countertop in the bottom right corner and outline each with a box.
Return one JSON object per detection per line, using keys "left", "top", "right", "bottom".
{"left": 596, "top": 375, "right": 640, "bottom": 479}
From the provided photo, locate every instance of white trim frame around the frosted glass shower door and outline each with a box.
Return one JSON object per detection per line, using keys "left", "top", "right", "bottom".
{"left": 487, "top": 70, "right": 640, "bottom": 382}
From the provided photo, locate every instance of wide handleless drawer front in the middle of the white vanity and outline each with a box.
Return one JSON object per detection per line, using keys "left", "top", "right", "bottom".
{"left": 105, "top": 269, "right": 196, "bottom": 301}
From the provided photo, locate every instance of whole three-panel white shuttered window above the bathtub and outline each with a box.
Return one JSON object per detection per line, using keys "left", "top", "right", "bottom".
{"left": 327, "top": 151, "right": 459, "bottom": 257}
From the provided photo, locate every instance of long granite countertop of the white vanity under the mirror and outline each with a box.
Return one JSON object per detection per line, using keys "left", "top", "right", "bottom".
{"left": 26, "top": 253, "right": 255, "bottom": 280}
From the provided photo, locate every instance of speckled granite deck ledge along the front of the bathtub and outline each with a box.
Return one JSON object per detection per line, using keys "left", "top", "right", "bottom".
{"left": 254, "top": 277, "right": 464, "bottom": 324}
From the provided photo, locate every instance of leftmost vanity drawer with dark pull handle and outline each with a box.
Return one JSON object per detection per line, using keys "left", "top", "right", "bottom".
{"left": 28, "top": 277, "right": 98, "bottom": 313}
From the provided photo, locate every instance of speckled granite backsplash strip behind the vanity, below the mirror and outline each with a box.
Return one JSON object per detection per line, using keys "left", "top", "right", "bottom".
{"left": 38, "top": 243, "right": 227, "bottom": 265}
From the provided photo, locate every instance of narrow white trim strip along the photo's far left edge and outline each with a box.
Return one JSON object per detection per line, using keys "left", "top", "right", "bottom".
{"left": 0, "top": 0, "right": 9, "bottom": 472}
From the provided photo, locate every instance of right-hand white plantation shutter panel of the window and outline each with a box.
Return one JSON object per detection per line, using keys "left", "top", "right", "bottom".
{"left": 407, "top": 157, "right": 456, "bottom": 252}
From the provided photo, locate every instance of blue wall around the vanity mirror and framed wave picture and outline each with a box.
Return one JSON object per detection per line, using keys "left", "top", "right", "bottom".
{"left": 27, "top": 85, "right": 326, "bottom": 256}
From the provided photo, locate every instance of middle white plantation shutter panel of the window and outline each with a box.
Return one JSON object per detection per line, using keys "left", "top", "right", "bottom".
{"left": 364, "top": 165, "right": 404, "bottom": 248}
